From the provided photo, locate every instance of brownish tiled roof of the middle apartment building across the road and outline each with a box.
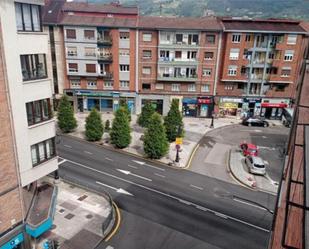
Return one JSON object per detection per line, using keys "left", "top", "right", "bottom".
{"left": 138, "top": 16, "right": 222, "bottom": 30}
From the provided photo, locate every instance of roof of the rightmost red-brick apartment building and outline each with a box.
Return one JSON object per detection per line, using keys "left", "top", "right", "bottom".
{"left": 221, "top": 18, "right": 306, "bottom": 33}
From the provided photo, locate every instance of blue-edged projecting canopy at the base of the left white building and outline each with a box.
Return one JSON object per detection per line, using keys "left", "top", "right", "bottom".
{"left": 26, "top": 183, "right": 58, "bottom": 238}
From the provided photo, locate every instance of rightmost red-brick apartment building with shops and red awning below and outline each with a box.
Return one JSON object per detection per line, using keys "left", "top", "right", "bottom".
{"left": 216, "top": 18, "right": 307, "bottom": 119}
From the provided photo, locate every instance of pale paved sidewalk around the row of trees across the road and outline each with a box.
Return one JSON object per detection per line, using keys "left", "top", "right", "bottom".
{"left": 70, "top": 113, "right": 240, "bottom": 168}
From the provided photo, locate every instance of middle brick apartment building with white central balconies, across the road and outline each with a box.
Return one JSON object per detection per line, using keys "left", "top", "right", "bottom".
{"left": 137, "top": 16, "right": 221, "bottom": 117}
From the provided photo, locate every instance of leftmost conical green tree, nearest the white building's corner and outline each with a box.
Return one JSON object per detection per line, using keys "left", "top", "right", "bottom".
{"left": 57, "top": 95, "right": 77, "bottom": 133}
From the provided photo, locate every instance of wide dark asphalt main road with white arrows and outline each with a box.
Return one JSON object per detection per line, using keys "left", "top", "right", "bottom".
{"left": 57, "top": 137, "right": 275, "bottom": 249}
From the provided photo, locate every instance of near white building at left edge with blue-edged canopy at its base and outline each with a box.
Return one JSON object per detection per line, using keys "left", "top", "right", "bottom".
{"left": 0, "top": 0, "right": 58, "bottom": 249}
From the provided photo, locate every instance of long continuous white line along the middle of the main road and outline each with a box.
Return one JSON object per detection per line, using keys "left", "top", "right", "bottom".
{"left": 61, "top": 159, "right": 269, "bottom": 233}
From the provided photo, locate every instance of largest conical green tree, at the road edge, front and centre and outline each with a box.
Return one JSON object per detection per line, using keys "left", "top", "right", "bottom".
{"left": 144, "top": 113, "right": 169, "bottom": 159}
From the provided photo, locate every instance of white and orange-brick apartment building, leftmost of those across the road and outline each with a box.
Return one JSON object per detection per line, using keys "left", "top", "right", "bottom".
{"left": 43, "top": 1, "right": 138, "bottom": 112}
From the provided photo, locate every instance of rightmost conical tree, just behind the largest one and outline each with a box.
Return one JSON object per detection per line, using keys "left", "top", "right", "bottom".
{"left": 164, "top": 99, "right": 183, "bottom": 142}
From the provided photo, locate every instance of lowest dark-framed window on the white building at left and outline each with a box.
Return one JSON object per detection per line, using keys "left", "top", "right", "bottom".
{"left": 31, "top": 138, "right": 56, "bottom": 166}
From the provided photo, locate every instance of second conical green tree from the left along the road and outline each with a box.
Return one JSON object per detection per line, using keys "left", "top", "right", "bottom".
{"left": 85, "top": 108, "right": 104, "bottom": 141}
